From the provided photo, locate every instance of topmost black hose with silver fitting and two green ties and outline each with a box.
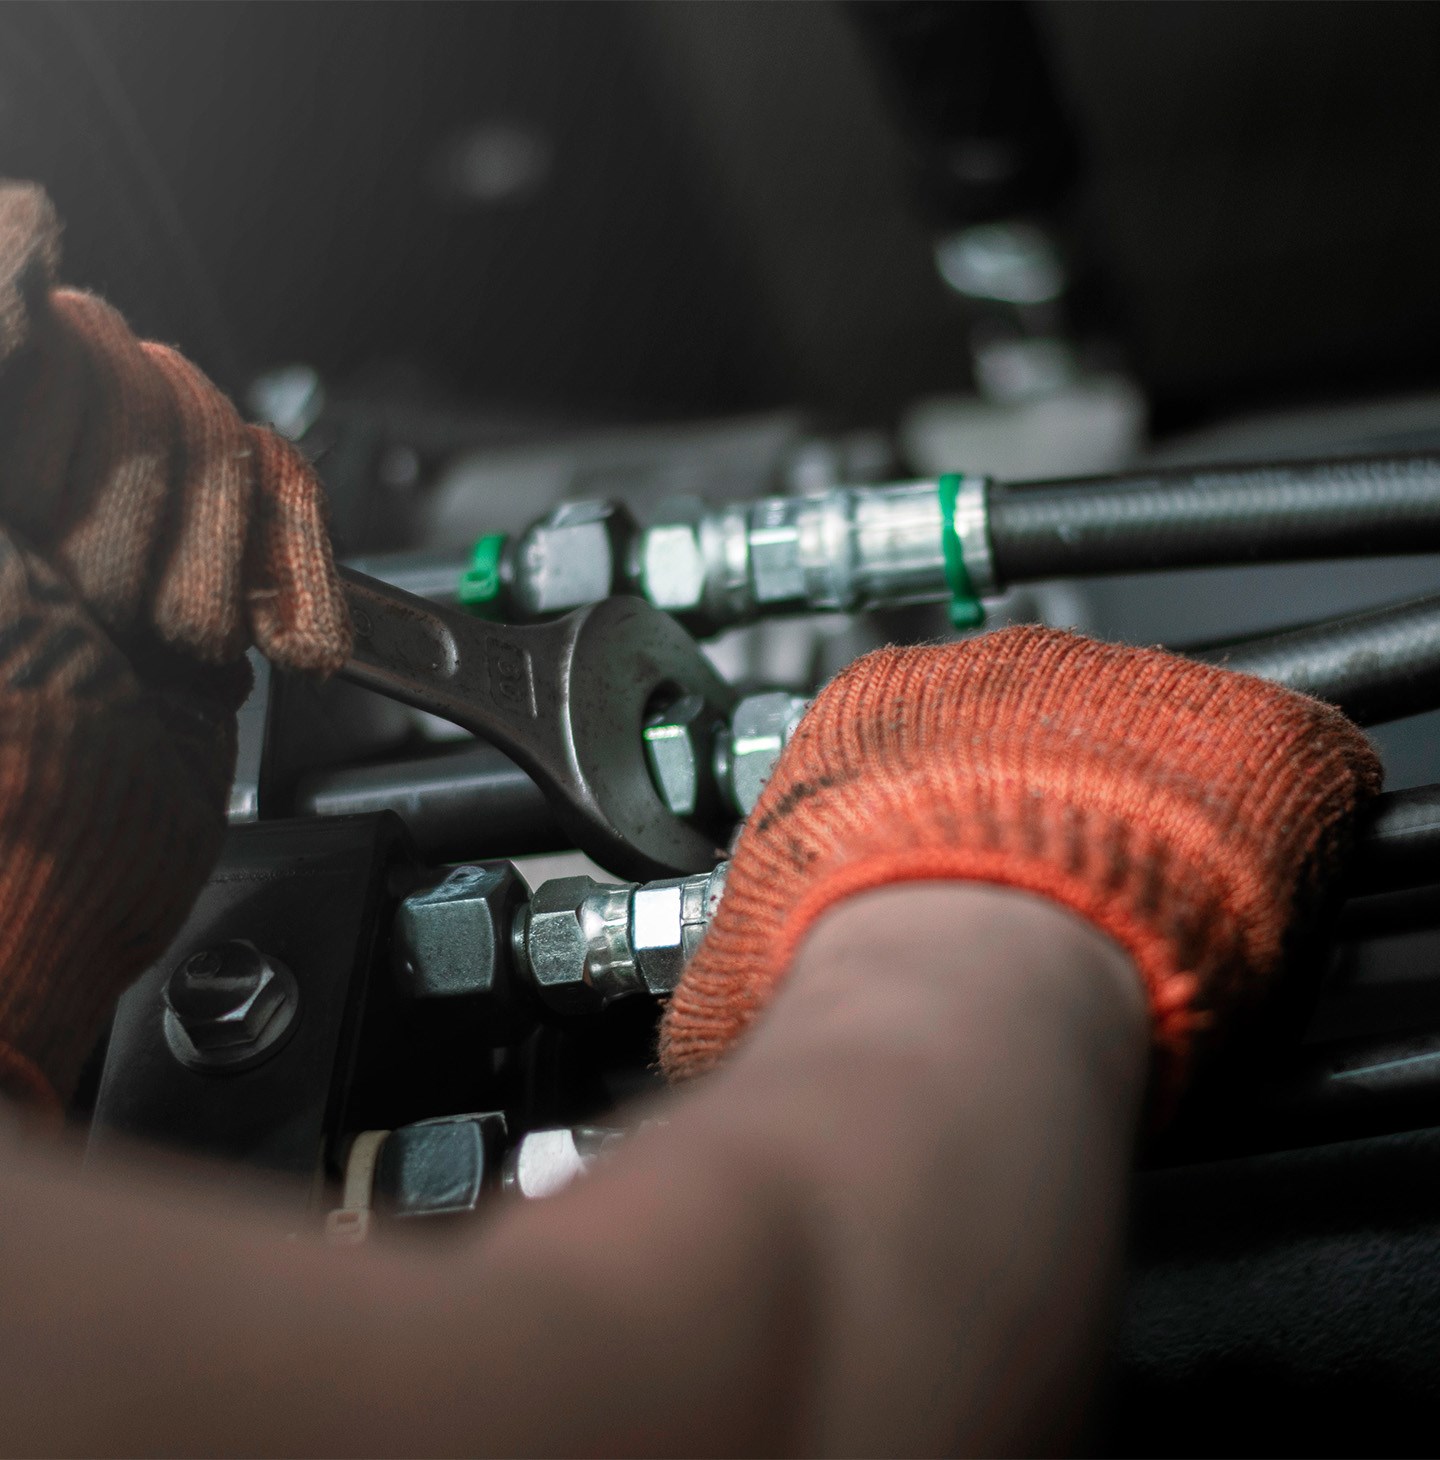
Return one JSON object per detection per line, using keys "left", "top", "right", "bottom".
{"left": 462, "top": 454, "right": 1440, "bottom": 632}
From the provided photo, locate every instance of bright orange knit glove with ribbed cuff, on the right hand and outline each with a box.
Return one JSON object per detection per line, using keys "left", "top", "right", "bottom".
{"left": 660, "top": 628, "right": 1380, "bottom": 1091}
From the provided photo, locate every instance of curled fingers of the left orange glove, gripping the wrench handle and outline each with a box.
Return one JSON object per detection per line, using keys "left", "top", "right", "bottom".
{"left": 0, "top": 184, "right": 349, "bottom": 672}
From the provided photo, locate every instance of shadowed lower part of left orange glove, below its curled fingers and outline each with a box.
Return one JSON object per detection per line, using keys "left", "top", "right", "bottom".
{"left": 0, "top": 533, "right": 250, "bottom": 1107}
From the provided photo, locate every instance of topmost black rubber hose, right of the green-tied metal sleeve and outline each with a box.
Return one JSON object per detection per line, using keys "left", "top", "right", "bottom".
{"left": 990, "top": 453, "right": 1440, "bottom": 585}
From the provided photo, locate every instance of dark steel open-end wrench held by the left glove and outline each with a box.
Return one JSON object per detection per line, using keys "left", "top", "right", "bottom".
{"left": 340, "top": 568, "right": 735, "bottom": 880}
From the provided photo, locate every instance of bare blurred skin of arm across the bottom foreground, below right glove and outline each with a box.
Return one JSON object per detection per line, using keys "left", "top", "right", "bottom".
{"left": 0, "top": 888, "right": 1145, "bottom": 1453}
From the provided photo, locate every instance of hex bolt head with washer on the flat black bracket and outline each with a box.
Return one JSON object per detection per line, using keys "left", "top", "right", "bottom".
{"left": 164, "top": 939, "right": 299, "bottom": 1073}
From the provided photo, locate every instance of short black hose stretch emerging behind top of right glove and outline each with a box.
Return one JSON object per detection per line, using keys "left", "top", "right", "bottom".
{"left": 1192, "top": 594, "right": 1440, "bottom": 726}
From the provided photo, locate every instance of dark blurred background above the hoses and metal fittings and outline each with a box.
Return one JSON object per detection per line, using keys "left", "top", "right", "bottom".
{"left": 8, "top": 0, "right": 1440, "bottom": 432}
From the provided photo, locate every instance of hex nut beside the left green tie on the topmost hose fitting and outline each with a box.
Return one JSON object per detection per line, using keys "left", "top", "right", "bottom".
{"left": 510, "top": 502, "right": 637, "bottom": 618}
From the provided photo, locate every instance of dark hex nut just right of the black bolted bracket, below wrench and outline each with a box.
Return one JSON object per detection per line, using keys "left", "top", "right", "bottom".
{"left": 394, "top": 861, "right": 527, "bottom": 1019}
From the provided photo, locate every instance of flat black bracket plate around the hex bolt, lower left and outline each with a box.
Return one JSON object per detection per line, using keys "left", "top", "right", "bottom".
{"left": 89, "top": 816, "right": 414, "bottom": 1191}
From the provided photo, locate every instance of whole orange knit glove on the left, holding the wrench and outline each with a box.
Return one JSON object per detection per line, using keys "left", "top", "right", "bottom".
{"left": 0, "top": 185, "right": 351, "bottom": 1104}
